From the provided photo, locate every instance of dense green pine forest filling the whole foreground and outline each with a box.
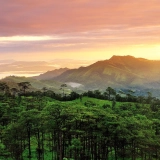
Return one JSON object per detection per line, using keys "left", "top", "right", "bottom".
{"left": 0, "top": 82, "right": 160, "bottom": 160}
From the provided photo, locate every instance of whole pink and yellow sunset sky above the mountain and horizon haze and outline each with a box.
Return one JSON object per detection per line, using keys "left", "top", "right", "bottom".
{"left": 0, "top": 0, "right": 160, "bottom": 61}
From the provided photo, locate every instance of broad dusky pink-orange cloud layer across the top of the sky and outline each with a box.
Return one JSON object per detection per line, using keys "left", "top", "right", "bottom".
{"left": 0, "top": 0, "right": 160, "bottom": 36}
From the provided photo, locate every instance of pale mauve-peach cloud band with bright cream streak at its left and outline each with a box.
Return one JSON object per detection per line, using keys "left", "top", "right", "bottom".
{"left": 0, "top": 25, "right": 160, "bottom": 53}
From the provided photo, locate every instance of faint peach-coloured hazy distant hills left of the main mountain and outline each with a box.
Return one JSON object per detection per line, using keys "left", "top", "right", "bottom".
{"left": 0, "top": 59, "right": 93, "bottom": 79}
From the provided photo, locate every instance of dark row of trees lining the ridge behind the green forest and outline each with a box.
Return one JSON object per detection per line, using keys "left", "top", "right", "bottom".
{"left": 0, "top": 82, "right": 155, "bottom": 103}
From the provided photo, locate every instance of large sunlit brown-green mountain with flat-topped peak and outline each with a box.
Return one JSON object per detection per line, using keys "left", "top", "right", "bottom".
{"left": 53, "top": 56, "right": 160, "bottom": 89}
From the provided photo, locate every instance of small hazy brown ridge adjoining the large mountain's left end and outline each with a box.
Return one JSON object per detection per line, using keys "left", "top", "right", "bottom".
{"left": 32, "top": 68, "right": 69, "bottom": 80}
